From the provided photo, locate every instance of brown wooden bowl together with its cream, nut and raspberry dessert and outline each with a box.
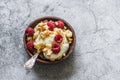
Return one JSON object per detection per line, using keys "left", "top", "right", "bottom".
{"left": 24, "top": 16, "right": 76, "bottom": 64}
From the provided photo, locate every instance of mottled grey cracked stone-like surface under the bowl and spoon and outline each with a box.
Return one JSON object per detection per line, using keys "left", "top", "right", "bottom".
{"left": 0, "top": 0, "right": 120, "bottom": 80}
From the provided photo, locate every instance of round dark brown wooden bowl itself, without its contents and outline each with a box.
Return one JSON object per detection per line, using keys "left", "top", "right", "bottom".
{"left": 24, "top": 16, "right": 76, "bottom": 64}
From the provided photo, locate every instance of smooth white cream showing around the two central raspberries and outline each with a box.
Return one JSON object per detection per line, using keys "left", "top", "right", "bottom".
{"left": 43, "top": 34, "right": 69, "bottom": 61}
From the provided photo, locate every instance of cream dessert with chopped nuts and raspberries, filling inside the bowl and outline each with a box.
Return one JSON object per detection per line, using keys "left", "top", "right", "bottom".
{"left": 26, "top": 20, "right": 72, "bottom": 61}
